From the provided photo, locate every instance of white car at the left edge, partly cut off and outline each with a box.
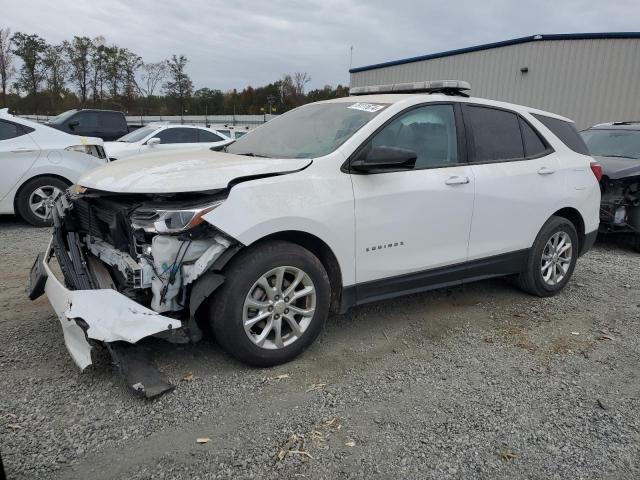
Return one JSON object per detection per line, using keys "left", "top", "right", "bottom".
{"left": 0, "top": 108, "right": 107, "bottom": 227}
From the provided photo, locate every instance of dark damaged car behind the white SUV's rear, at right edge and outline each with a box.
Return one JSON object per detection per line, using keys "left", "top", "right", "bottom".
{"left": 581, "top": 122, "right": 640, "bottom": 252}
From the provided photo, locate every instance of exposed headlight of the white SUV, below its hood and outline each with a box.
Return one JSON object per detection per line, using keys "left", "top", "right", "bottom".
{"left": 131, "top": 200, "right": 224, "bottom": 233}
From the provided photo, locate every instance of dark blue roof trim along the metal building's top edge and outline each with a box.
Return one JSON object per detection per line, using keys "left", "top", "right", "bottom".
{"left": 349, "top": 32, "right": 640, "bottom": 73}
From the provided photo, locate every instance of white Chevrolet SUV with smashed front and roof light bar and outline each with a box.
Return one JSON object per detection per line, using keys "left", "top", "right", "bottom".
{"left": 31, "top": 81, "right": 600, "bottom": 382}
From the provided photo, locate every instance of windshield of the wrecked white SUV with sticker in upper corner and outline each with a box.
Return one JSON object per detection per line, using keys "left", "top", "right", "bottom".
{"left": 227, "top": 102, "right": 387, "bottom": 158}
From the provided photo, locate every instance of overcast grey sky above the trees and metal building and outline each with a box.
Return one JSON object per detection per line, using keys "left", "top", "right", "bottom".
{"left": 5, "top": 0, "right": 640, "bottom": 90}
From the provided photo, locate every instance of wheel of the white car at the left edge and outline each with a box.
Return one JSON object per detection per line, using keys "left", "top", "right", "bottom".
{"left": 16, "top": 177, "right": 69, "bottom": 227}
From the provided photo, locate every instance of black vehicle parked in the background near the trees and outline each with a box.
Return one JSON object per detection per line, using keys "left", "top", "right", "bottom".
{"left": 47, "top": 109, "right": 130, "bottom": 141}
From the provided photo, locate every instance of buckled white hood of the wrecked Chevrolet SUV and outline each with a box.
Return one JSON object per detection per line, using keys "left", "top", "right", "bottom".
{"left": 78, "top": 148, "right": 311, "bottom": 193}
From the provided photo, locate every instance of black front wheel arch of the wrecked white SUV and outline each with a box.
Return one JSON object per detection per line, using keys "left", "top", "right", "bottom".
{"left": 247, "top": 230, "right": 343, "bottom": 313}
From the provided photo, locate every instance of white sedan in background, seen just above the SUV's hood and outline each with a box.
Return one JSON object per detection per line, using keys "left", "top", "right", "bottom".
{"left": 104, "top": 124, "right": 233, "bottom": 160}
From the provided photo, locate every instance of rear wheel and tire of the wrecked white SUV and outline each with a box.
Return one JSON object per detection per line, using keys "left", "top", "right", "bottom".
{"left": 517, "top": 216, "right": 579, "bottom": 297}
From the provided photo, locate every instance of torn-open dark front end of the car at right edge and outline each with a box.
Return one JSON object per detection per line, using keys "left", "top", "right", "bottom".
{"left": 600, "top": 175, "right": 640, "bottom": 239}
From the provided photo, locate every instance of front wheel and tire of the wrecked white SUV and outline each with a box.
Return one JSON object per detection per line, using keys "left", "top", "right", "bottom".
{"left": 209, "top": 241, "right": 331, "bottom": 367}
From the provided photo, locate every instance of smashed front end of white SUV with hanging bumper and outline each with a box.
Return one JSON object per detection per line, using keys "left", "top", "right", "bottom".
{"left": 29, "top": 188, "right": 241, "bottom": 397}
